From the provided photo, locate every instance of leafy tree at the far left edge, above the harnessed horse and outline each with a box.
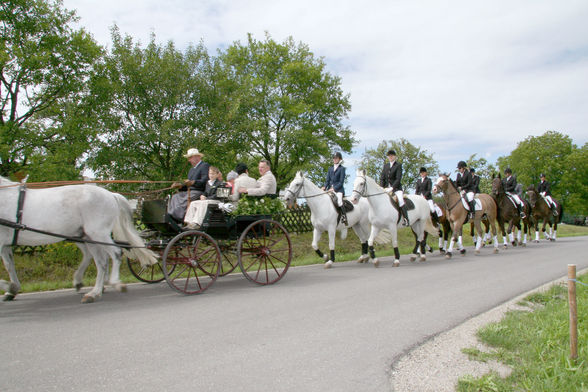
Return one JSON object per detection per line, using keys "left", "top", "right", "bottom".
{"left": 0, "top": 0, "right": 102, "bottom": 179}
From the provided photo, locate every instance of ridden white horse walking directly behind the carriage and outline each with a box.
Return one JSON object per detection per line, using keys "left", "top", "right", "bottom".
{"left": 285, "top": 172, "right": 370, "bottom": 268}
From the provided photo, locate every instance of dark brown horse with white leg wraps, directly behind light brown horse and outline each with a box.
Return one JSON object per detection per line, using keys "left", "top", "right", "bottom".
{"left": 492, "top": 174, "right": 530, "bottom": 249}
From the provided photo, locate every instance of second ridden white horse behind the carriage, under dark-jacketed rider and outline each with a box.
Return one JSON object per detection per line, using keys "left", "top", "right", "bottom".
{"left": 352, "top": 170, "right": 439, "bottom": 267}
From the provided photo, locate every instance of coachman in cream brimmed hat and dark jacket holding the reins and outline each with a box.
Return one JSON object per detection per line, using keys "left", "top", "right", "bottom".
{"left": 167, "top": 148, "right": 210, "bottom": 222}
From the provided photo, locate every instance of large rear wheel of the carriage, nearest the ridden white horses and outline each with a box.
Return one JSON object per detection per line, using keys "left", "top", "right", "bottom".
{"left": 237, "top": 219, "right": 292, "bottom": 285}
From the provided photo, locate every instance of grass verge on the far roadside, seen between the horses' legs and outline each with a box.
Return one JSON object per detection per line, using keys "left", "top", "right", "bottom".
{"left": 0, "top": 225, "right": 588, "bottom": 292}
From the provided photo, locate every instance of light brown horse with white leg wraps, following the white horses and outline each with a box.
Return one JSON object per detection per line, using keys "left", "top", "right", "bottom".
{"left": 433, "top": 174, "right": 498, "bottom": 258}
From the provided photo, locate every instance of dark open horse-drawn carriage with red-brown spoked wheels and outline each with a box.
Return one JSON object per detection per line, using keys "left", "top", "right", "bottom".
{"left": 128, "top": 188, "right": 292, "bottom": 294}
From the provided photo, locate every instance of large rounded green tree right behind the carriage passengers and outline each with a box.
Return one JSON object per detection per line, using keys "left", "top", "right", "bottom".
{"left": 215, "top": 35, "right": 355, "bottom": 186}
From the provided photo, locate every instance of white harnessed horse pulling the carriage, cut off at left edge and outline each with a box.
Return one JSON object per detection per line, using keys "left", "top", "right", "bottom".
{"left": 0, "top": 177, "right": 157, "bottom": 303}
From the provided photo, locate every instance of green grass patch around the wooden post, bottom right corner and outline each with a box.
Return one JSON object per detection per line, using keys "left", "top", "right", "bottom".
{"left": 457, "top": 275, "right": 588, "bottom": 392}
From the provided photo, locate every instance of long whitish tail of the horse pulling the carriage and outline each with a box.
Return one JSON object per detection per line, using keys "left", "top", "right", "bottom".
{"left": 112, "top": 193, "right": 158, "bottom": 266}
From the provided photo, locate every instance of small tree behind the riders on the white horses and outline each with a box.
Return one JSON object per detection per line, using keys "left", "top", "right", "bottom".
{"left": 360, "top": 138, "right": 439, "bottom": 192}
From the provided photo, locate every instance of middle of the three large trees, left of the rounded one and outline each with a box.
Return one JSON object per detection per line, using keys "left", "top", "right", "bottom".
{"left": 88, "top": 26, "right": 208, "bottom": 184}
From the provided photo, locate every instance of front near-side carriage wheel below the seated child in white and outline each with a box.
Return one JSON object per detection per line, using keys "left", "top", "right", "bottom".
{"left": 162, "top": 231, "right": 221, "bottom": 294}
